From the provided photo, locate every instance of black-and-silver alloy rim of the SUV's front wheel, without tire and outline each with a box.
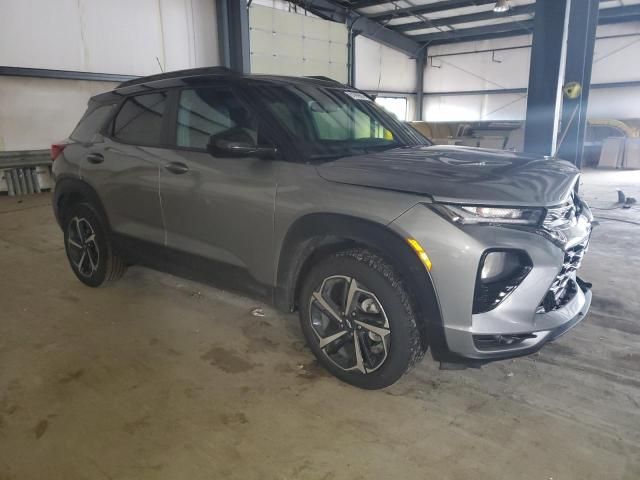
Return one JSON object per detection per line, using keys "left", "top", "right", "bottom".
{"left": 309, "top": 275, "right": 391, "bottom": 374}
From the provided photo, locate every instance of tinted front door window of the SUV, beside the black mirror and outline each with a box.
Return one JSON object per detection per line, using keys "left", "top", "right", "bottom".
{"left": 176, "top": 88, "right": 258, "bottom": 149}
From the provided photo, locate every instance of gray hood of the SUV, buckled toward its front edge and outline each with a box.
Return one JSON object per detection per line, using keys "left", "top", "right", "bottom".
{"left": 317, "top": 145, "right": 579, "bottom": 207}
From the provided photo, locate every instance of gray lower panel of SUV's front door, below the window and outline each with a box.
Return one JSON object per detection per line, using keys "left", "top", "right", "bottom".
{"left": 161, "top": 150, "right": 278, "bottom": 284}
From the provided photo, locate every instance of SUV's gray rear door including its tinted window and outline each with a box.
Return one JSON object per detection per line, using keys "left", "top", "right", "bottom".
{"left": 80, "top": 91, "right": 168, "bottom": 244}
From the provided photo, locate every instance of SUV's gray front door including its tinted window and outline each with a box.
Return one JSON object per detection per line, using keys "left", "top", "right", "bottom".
{"left": 161, "top": 84, "right": 279, "bottom": 284}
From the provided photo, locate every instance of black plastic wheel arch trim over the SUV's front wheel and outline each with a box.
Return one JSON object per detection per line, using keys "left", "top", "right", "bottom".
{"left": 274, "top": 213, "right": 447, "bottom": 357}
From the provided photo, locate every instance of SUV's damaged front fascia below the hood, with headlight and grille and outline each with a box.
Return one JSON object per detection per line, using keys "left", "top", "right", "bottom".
{"left": 393, "top": 189, "right": 592, "bottom": 360}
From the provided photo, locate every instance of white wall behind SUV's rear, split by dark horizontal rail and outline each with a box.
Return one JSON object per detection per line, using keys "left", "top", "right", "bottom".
{"left": 0, "top": 0, "right": 219, "bottom": 150}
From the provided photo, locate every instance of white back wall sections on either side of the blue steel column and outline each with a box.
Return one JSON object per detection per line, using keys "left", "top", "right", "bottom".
{"left": 424, "top": 23, "right": 640, "bottom": 121}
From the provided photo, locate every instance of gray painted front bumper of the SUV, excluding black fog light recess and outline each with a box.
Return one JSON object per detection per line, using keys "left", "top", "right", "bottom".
{"left": 391, "top": 205, "right": 591, "bottom": 361}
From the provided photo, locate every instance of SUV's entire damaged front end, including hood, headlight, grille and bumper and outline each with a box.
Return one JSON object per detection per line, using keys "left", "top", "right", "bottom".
{"left": 318, "top": 145, "right": 592, "bottom": 360}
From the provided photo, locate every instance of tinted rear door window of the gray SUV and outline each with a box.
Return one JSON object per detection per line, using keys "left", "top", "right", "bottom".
{"left": 113, "top": 92, "right": 167, "bottom": 145}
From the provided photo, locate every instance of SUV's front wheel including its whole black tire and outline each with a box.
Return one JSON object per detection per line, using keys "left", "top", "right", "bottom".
{"left": 299, "top": 248, "right": 426, "bottom": 390}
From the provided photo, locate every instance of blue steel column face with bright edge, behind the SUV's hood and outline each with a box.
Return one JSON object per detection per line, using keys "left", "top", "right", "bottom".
{"left": 524, "top": 0, "right": 571, "bottom": 155}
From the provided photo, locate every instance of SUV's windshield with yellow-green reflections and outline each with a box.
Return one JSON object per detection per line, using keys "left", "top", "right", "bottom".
{"left": 245, "top": 82, "right": 429, "bottom": 160}
